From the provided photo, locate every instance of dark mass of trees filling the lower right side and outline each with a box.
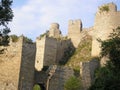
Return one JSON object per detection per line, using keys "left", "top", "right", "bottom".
{"left": 90, "top": 27, "right": 120, "bottom": 90}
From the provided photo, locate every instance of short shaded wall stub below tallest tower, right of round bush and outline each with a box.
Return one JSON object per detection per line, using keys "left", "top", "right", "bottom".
{"left": 80, "top": 60, "right": 99, "bottom": 90}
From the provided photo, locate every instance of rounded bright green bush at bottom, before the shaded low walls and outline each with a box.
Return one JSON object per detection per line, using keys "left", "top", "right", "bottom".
{"left": 64, "top": 77, "right": 81, "bottom": 90}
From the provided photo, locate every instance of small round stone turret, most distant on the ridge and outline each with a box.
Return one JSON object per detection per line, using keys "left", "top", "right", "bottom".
{"left": 49, "top": 23, "right": 61, "bottom": 38}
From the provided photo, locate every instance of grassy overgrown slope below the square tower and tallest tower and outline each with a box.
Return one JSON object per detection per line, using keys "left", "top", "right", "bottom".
{"left": 66, "top": 35, "right": 92, "bottom": 71}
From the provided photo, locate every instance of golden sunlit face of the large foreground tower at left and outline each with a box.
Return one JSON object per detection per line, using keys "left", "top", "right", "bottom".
{"left": 0, "top": 37, "right": 23, "bottom": 90}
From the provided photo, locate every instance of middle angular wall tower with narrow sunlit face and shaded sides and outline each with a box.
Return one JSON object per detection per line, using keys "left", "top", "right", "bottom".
{"left": 35, "top": 36, "right": 73, "bottom": 71}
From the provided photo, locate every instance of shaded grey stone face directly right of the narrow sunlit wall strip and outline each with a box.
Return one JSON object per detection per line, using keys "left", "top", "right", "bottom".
{"left": 44, "top": 37, "right": 57, "bottom": 66}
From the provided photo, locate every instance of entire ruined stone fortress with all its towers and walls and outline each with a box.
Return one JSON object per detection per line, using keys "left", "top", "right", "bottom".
{"left": 0, "top": 3, "right": 120, "bottom": 90}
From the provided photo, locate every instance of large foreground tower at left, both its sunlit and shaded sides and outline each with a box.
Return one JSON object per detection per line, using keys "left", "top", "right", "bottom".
{"left": 0, "top": 36, "right": 36, "bottom": 90}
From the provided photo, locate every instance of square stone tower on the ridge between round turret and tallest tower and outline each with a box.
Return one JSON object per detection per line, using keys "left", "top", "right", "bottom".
{"left": 68, "top": 20, "right": 82, "bottom": 47}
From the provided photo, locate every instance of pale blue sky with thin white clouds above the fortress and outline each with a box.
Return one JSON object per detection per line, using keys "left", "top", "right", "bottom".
{"left": 10, "top": 0, "right": 120, "bottom": 41}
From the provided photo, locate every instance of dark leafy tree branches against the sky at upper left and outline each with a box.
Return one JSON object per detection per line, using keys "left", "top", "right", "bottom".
{"left": 0, "top": 0, "right": 13, "bottom": 45}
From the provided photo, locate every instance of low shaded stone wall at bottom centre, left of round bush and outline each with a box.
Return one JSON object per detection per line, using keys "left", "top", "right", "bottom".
{"left": 48, "top": 66, "right": 74, "bottom": 90}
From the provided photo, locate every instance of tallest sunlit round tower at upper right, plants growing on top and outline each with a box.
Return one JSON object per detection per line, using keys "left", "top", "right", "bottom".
{"left": 92, "top": 3, "right": 120, "bottom": 56}
